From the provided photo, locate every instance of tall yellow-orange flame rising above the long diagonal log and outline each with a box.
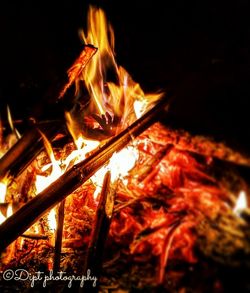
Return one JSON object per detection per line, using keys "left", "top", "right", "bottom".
{"left": 81, "top": 6, "right": 161, "bottom": 127}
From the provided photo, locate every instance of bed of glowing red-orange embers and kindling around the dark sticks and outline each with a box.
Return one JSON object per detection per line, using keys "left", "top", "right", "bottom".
{"left": 1, "top": 123, "right": 250, "bottom": 292}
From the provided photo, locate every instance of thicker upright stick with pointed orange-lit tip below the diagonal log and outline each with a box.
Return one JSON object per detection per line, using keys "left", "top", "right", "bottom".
{"left": 82, "top": 171, "right": 115, "bottom": 292}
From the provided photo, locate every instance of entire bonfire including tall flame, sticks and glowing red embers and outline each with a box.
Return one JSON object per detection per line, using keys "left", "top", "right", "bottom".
{"left": 0, "top": 8, "right": 250, "bottom": 292}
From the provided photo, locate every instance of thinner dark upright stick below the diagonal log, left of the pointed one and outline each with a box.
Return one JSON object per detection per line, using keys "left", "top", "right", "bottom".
{"left": 53, "top": 200, "right": 65, "bottom": 273}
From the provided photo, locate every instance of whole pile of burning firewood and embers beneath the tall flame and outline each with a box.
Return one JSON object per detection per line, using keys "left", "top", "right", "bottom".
{"left": 0, "top": 4, "right": 250, "bottom": 293}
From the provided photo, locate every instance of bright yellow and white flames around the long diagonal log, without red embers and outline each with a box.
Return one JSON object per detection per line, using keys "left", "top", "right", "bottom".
{"left": 0, "top": 7, "right": 161, "bottom": 270}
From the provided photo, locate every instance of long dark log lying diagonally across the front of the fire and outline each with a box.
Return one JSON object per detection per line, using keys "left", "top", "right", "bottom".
{"left": 0, "top": 96, "right": 169, "bottom": 251}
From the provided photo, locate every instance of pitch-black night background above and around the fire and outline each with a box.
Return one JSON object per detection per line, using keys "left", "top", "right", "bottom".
{"left": 0, "top": 0, "right": 250, "bottom": 152}
